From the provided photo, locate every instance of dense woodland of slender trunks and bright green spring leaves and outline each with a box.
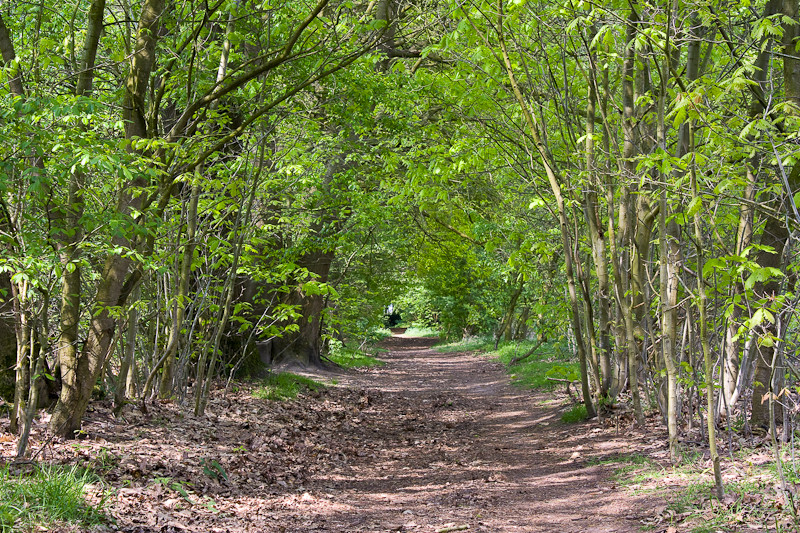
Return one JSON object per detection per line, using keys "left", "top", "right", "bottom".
{"left": 0, "top": 0, "right": 800, "bottom": 490}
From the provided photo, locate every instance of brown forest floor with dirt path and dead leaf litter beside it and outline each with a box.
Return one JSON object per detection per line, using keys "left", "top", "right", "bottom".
{"left": 0, "top": 337, "right": 712, "bottom": 533}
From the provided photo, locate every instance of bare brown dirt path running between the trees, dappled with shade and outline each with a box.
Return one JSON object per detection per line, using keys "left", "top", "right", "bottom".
{"left": 316, "top": 338, "right": 659, "bottom": 533}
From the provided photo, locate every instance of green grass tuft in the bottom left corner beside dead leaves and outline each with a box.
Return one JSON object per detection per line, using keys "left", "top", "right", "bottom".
{"left": 0, "top": 466, "right": 106, "bottom": 533}
